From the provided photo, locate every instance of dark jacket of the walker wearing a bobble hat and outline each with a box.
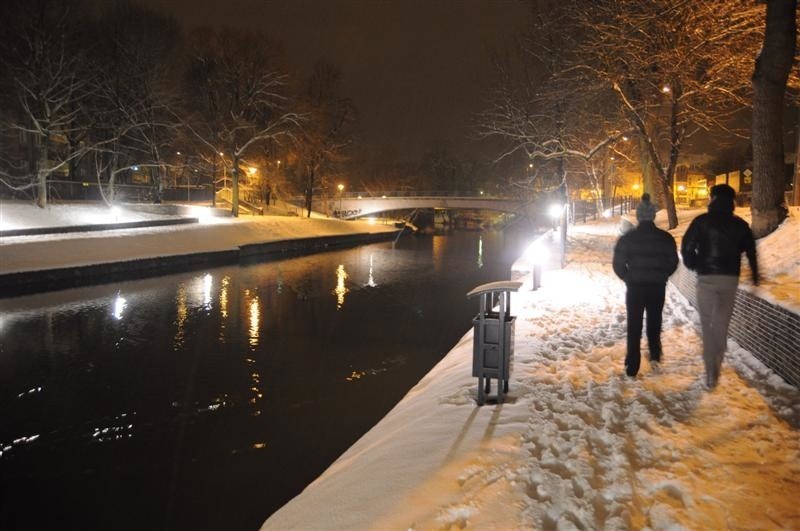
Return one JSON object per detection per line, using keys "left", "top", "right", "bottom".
{"left": 612, "top": 221, "right": 678, "bottom": 284}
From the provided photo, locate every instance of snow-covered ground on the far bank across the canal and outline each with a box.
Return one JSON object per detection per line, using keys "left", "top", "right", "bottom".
{"left": 0, "top": 200, "right": 397, "bottom": 274}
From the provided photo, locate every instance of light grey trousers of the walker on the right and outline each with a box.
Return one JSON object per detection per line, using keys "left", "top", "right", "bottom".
{"left": 697, "top": 275, "right": 739, "bottom": 387}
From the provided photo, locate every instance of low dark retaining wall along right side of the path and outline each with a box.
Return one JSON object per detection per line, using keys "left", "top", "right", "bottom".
{"left": 671, "top": 264, "right": 800, "bottom": 387}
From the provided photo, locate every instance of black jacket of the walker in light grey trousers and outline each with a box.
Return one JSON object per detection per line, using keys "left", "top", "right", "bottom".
{"left": 681, "top": 208, "right": 758, "bottom": 284}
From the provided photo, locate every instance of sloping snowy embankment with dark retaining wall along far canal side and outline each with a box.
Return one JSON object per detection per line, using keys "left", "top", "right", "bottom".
{"left": 0, "top": 218, "right": 399, "bottom": 297}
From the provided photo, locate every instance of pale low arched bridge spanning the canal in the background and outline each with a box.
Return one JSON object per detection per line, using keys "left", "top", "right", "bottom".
{"left": 295, "top": 191, "right": 529, "bottom": 219}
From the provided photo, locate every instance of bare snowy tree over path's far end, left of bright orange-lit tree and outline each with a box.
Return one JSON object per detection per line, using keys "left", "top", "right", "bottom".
{"left": 478, "top": 0, "right": 629, "bottom": 214}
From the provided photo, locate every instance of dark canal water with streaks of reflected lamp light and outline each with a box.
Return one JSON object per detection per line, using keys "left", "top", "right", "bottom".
{"left": 0, "top": 227, "right": 530, "bottom": 530}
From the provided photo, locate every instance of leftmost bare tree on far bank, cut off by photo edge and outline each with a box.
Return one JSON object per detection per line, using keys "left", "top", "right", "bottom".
{"left": 0, "top": 0, "right": 91, "bottom": 208}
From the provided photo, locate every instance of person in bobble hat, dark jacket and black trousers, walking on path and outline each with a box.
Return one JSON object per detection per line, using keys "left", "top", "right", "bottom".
{"left": 612, "top": 194, "right": 678, "bottom": 377}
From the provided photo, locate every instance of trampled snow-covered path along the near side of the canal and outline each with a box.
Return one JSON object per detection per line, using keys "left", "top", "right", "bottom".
{"left": 265, "top": 225, "right": 800, "bottom": 529}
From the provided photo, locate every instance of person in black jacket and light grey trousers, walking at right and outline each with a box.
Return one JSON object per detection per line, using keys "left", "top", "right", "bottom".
{"left": 681, "top": 184, "right": 759, "bottom": 389}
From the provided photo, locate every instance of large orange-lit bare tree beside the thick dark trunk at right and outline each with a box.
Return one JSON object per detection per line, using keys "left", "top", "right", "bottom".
{"left": 581, "top": 0, "right": 760, "bottom": 228}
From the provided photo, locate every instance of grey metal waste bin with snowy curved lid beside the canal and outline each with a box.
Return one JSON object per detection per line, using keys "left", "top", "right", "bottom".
{"left": 467, "top": 281, "right": 522, "bottom": 406}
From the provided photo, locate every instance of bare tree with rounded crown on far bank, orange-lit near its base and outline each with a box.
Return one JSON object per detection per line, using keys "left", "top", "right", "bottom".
{"left": 184, "top": 29, "right": 299, "bottom": 216}
